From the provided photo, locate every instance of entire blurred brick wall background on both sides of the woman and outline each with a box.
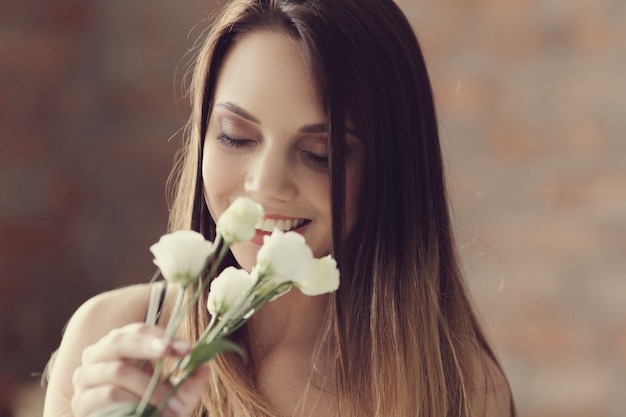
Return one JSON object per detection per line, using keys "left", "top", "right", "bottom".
{"left": 0, "top": 0, "right": 626, "bottom": 417}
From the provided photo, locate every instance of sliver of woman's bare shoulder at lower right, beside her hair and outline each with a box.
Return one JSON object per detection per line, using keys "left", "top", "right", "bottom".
{"left": 471, "top": 354, "right": 515, "bottom": 417}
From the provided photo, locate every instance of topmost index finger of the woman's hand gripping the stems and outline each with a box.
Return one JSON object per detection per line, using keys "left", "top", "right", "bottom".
{"left": 82, "top": 323, "right": 190, "bottom": 363}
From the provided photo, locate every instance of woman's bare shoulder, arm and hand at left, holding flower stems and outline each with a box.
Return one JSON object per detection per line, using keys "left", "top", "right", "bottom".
{"left": 43, "top": 284, "right": 209, "bottom": 417}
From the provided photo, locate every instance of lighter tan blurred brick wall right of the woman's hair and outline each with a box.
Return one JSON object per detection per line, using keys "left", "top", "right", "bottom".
{"left": 401, "top": 0, "right": 626, "bottom": 417}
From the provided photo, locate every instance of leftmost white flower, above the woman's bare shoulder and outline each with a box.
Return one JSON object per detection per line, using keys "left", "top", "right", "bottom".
{"left": 150, "top": 230, "right": 214, "bottom": 286}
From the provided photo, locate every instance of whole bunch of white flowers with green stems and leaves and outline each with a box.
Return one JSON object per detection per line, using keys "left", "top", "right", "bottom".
{"left": 91, "top": 198, "right": 339, "bottom": 417}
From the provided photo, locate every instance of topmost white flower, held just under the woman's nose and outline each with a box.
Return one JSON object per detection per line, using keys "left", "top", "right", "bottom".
{"left": 216, "top": 197, "right": 263, "bottom": 245}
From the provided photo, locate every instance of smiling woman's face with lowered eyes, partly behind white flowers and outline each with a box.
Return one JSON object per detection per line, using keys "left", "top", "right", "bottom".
{"left": 202, "top": 31, "right": 363, "bottom": 270}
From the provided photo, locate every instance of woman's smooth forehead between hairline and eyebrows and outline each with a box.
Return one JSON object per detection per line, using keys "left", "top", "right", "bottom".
{"left": 214, "top": 31, "right": 324, "bottom": 124}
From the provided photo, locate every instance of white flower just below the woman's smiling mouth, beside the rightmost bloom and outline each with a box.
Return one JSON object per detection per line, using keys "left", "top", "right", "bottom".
{"left": 257, "top": 229, "right": 314, "bottom": 285}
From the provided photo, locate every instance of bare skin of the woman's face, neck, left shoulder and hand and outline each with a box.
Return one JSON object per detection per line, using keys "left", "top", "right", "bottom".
{"left": 44, "top": 32, "right": 362, "bottom": 417}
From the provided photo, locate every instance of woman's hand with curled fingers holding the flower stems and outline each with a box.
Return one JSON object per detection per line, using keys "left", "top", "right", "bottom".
{"left": 71, "top": 323, "right": 209, "bottom": 417}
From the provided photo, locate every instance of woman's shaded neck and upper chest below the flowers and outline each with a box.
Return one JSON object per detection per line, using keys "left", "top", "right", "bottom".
{"left": 241, "top": 289, "right": 336, "bottom": 416}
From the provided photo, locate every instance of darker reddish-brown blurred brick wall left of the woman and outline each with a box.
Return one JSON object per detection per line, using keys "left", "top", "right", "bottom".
{"left": 0, "top": 0, "right": 217, "bottom": 416}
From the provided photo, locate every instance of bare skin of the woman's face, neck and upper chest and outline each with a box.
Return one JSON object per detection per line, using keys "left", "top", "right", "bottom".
{"left": 202, "top": 31, "right": 363, "bottom": 416}
